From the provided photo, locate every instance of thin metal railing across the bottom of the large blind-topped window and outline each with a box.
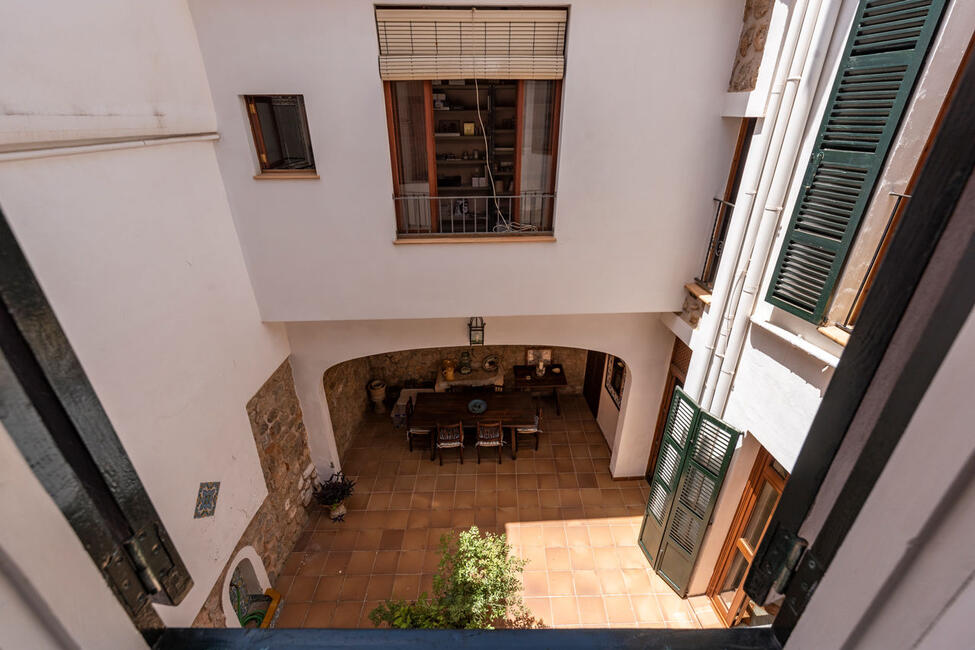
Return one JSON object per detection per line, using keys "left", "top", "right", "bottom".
{"left": 394, "top": 193, "right": 555, "bottom": 238}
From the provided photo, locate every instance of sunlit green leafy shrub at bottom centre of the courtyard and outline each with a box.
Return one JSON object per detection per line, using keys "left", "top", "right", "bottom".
{"left": 369, "top": 526, "right": 541, "bottom": 629}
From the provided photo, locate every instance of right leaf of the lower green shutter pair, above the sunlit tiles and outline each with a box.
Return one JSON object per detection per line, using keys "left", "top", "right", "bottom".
{"left": 654, "top": 412, "right": 740, "bottom": 597}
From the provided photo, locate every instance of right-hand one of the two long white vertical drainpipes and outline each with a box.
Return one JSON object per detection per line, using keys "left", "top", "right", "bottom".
{"left": 710, "top": 0, "right": 842, "bottom": 414}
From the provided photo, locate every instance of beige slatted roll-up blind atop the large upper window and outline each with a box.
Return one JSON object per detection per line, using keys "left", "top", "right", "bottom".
{"left": 376, "top": 9, "right": 568, "bottom": 81}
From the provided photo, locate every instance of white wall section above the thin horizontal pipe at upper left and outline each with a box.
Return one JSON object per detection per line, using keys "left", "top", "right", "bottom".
{"left": 0, "top": 0, "right": 216, "bottom": 151}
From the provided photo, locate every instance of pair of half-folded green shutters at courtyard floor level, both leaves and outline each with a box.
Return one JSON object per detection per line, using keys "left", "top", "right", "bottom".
{"left": 639, "top": 388, "right": 741, "bottom": 596}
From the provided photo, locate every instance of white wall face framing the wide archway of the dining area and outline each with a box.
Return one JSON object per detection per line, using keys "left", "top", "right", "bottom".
{"left": 287, "top": 314, "right": 674, "bottom": 477}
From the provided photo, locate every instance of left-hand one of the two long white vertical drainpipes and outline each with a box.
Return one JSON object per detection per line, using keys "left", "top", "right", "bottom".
{"left": 684, "top": 0, "right": 818, "bottom": 401}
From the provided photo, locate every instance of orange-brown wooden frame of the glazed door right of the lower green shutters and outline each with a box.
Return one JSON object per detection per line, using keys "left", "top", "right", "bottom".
{"left": 705, "top": 447, "right": 787, "bottom": 627}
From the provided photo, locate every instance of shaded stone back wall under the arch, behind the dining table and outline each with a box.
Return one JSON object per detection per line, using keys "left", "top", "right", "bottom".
{"left": 323, "top": 345, "right": 587, "bottom": 462}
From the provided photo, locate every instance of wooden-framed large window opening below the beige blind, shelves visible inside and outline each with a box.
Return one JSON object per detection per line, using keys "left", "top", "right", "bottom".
{"left": 385, "top": 79, "right": 561, "bottom": 238}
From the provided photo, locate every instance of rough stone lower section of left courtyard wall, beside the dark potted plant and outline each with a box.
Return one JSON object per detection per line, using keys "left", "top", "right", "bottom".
{"left": 193, "top": 359, "right": 318, "bottom": 627}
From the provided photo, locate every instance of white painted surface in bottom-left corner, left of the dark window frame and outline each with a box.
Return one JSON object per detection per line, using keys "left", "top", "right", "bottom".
{"left": 0, "top": 424, "right": 146, "bottom": 650}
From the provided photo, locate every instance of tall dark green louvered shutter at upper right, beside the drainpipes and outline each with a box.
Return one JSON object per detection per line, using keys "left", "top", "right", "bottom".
{"left": 766, "top": 0, "right": 946, "bottom": 324}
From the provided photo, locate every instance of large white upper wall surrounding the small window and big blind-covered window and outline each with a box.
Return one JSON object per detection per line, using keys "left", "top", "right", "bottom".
{"left": 191, "top": 0, "right": 743, "bottom": 321}
